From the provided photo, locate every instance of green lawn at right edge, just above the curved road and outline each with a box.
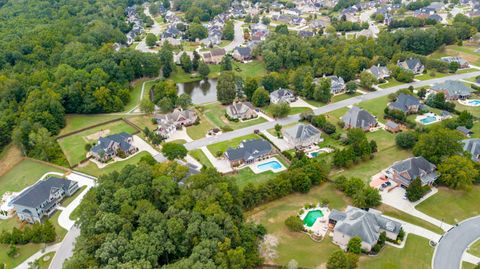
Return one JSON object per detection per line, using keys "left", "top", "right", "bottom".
{"left": 416, "top": 186, "right": 480, "bottom": 224}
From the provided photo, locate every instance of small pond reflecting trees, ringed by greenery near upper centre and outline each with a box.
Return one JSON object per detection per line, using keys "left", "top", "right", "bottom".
{"left": 177, "top": 79, "right": 217, "bottom": 105}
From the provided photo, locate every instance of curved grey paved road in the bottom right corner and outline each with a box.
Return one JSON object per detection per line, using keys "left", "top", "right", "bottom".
{"left": 432, "top": 216, "right": 480, "bottom": 269}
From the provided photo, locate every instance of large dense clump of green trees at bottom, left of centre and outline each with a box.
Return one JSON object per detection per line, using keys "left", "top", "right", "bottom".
{"left": 65, "top": 160, "right": 265, "bottom": 268}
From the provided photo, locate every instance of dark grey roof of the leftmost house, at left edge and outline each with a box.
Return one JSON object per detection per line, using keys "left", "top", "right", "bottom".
{"left": 12, "top": 177, "right": 74, "bottom": 208}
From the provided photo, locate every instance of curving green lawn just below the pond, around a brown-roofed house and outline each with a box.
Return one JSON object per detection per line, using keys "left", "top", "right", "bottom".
{"left": 203, "top": 103, "right": 267, "bottom": 130}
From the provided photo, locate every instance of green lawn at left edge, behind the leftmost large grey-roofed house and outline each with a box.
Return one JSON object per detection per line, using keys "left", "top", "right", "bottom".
{"left": 0, "top": 159, "right": 65, "bottom": 195}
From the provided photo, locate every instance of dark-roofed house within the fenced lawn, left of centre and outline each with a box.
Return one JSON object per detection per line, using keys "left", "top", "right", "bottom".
{"left": 89, "top": 132, "right": 138, "bottom": 162}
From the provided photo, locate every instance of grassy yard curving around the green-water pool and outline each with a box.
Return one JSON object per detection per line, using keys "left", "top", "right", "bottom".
{"left": 246, "top": 183, "right": 349, "bottom": 268}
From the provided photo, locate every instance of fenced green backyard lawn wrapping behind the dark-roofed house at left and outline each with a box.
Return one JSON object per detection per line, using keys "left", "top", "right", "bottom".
{"left": 58, "top": 121, "right": 136, "bottom": 166}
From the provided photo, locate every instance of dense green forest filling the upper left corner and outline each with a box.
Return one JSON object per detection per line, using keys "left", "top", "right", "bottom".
{"left": 0, "top": 0, "right": 160, "bottom": 159}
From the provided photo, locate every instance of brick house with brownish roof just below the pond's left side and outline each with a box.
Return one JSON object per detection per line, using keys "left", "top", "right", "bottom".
{"left": 155, "top": 109, "right": 198, "bottom": 138}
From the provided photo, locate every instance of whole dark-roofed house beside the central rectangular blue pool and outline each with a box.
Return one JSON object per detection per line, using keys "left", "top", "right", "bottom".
{"left": 225, "top": 139, "right": 273, "bottom": 166}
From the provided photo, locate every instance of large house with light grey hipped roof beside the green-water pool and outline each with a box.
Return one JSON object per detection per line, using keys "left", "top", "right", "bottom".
{"left": 329, "top": 206, "right": 402, "bottom": 252}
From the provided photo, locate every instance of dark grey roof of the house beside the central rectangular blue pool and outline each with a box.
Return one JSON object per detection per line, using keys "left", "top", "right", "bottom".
{"left": 225, "top": 139, "right": 272, "bottom": 161}
